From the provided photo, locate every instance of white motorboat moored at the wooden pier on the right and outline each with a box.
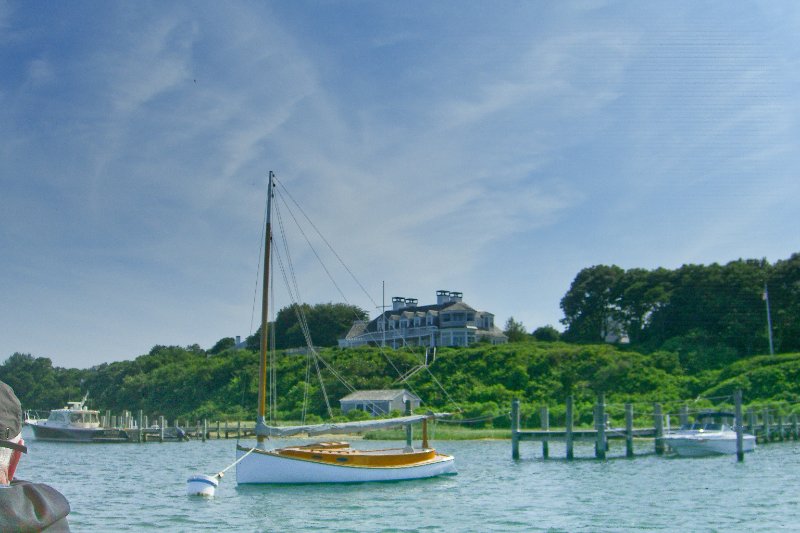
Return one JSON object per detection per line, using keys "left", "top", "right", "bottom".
{"left": 664, "top": 412, "right": 756, "bottom": 457}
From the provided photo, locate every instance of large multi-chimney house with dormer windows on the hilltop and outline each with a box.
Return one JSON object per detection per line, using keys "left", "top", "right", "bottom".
{"left": 339, "top": 290, "right": 508, "bottom": 348}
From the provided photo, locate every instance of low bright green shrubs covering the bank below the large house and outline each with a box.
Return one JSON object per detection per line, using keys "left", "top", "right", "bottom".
{"left": 6, "top": 339, "right": 800, "bottom": 427}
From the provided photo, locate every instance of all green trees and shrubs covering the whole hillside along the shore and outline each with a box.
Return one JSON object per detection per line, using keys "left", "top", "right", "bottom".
{"left": 0, "top": 254, "right": 800, "bottom": 420}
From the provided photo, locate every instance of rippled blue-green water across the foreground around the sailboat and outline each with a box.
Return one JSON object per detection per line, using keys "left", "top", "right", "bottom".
{"left": 17, "top": 426, "right": 800, "bottom": 532}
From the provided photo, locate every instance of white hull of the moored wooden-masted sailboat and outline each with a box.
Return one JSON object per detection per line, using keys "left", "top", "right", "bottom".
{"left": 236, "top": 448, "right": 456, "bottom": 484}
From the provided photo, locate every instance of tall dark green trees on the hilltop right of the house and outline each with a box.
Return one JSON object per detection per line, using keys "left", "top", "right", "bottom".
{"left": 561, "top": 254, "right": 800, "bottom": 372}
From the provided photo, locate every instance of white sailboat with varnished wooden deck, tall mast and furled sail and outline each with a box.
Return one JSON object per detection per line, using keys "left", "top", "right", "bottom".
{"left": 235, "top": 172, "right": 456, "bottom": 484}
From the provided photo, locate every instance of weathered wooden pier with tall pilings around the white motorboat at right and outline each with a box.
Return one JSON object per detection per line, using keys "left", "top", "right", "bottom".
{"left": 511, "top": 391, "right": 800, "bottom": 461}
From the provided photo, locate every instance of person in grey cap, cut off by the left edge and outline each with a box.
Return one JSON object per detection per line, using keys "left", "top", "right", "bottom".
{"left": 0, "top": 381, "right": 70, "bottom": 532}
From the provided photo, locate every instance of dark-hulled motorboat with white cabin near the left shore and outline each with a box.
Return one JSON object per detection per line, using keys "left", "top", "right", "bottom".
{"left": 27, "top": 396, "right": 129, "bottom": 442}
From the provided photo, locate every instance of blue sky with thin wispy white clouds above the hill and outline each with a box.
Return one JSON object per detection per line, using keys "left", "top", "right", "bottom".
{"left": 0, "top": 0, "right": 800, "bottom": 368}
